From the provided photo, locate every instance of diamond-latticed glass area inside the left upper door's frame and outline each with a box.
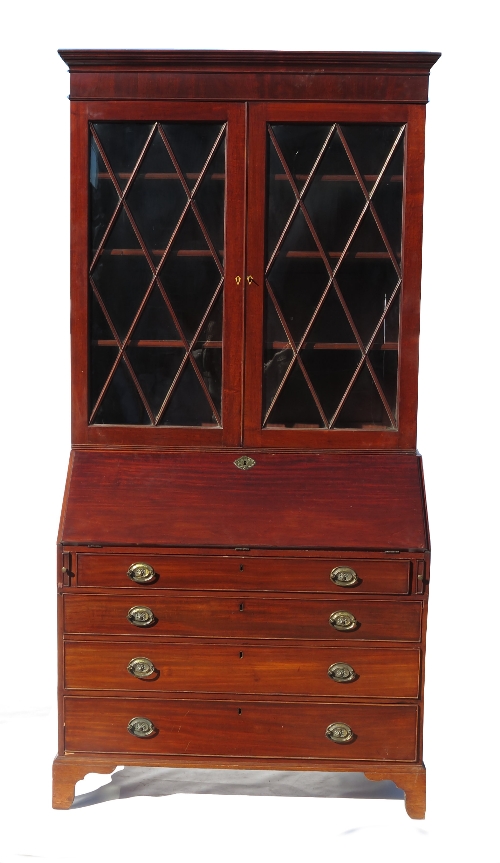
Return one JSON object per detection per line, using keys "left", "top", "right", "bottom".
{"left": 89, "top": 123, "right": 226, "bottom": 426}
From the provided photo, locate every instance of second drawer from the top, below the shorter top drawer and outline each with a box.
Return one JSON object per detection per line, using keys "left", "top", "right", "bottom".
{"left": 64, "top": 591, "right": 422, "bottom": 642}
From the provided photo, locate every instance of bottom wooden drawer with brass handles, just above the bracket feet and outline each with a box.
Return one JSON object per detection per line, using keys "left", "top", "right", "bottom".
{"left": 64, "top": 697, "right": 418, "bottom": 761}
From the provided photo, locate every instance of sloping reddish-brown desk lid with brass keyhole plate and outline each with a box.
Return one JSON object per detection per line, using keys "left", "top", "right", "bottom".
{"left": 59, "top": 450, "right": 429, "bottom": 550}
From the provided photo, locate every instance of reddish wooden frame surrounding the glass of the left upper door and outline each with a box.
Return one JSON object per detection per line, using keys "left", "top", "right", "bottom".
{"left": 71, "top": 101, "right": 246, "bottom": 447}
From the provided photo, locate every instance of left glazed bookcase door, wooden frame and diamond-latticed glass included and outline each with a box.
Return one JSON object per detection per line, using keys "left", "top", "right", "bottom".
{"left": 72, "top": 102, "right": 245, "bottom": 446}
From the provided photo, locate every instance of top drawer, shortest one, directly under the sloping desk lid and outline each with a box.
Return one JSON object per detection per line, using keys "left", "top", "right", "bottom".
{"left": 77, "top": 551, "right": 410, "bottom": 594}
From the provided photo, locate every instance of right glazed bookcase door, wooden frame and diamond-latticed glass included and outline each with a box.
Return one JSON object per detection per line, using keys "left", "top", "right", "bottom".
{"left": 244, "top": 104, "right": 424, "bottom": 449}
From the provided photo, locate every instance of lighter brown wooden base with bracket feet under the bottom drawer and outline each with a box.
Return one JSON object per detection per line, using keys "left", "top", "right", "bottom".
{"left": 52, "top": 755, "right": 425, "bottom": 819}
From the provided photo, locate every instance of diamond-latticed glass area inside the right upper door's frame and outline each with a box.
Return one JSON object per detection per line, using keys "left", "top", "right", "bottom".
{"left": 263, "top": 124, "right": 404, "bottom": 429}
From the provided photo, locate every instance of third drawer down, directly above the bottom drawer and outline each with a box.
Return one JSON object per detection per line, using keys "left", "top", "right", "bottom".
{"left": 64, "top": 640, "right": 420, "bottom": 698}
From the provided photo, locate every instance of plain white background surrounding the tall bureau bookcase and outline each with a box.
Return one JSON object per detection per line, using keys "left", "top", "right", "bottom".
{"left": 0, "top": 0, "right": 500, "bottom": 863}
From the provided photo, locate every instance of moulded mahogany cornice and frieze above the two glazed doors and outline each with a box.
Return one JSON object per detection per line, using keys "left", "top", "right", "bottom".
{"left": 59, "top": 50, "right": 440, "bottom": 102}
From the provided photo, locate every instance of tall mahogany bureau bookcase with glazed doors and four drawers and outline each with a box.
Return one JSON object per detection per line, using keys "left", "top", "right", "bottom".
{"left": 54, "top": 51, "right": 439, "bottom": 818}
